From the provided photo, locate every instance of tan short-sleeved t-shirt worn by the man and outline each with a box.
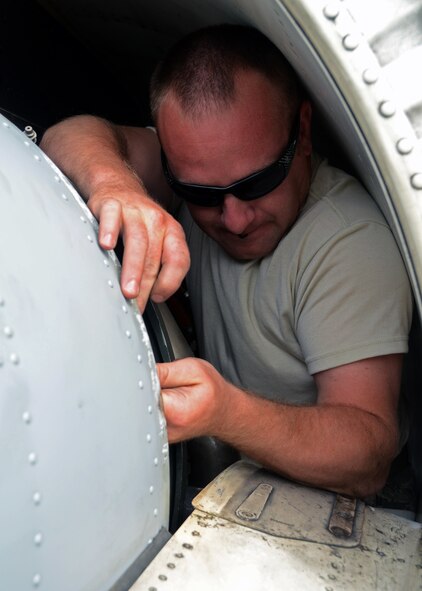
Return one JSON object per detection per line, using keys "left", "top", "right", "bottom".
{"left": 179, "top": 157, "right": 412, "bottom": 404}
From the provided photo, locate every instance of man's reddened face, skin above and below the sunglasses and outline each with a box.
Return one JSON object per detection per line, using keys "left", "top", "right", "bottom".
{"left": 157, "top": 71, "right": 311, "bottom": 260}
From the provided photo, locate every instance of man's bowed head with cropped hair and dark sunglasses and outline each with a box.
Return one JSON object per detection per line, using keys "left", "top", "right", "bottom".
{"left": 151, "top": 25, "right": 311, "bottom": 260}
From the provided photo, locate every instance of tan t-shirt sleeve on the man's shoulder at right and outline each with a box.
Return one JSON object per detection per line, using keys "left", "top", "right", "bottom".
{"left": 295, "top": 221, "right": 412, "bottom": 374}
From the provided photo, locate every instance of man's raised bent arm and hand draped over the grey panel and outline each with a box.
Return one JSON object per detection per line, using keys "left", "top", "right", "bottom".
{"left": 41, "top": 116, "right": 189, "bottom": 310}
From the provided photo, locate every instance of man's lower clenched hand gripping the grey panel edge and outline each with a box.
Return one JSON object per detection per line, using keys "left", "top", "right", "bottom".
{"left": 157, "top": 358, "right": 232, "bottom": 443}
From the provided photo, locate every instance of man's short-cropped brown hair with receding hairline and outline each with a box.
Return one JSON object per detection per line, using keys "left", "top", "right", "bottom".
{"left": 150, "top": 24, "right": 303, "bottom": 121}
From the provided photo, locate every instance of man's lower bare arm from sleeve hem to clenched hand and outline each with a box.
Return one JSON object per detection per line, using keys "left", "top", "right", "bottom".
{"left": 159, "top": 355, "right": 402, "bottom": 496}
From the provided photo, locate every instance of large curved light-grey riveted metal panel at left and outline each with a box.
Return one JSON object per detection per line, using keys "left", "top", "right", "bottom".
{"left": 0, "top": 117, "right": 169, "bottom": 591}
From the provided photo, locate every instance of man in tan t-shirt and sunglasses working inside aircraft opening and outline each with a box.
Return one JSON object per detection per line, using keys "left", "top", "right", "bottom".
{"left": 43, "top": 26, "right": 411, "bottom": 496}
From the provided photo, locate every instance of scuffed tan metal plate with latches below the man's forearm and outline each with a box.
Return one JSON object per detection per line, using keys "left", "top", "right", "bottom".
{"left": 193, "top": 462, "right": 364, "bottom": 547}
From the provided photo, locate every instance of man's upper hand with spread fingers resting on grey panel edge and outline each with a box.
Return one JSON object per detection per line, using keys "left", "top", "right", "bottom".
{"left": 88, "top": 183, "right": 190, "bottom": 312}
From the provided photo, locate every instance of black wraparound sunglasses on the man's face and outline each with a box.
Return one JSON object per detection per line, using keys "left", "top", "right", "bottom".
{"left": 161, "top": 113, "right": 300, "bottom": 207}
